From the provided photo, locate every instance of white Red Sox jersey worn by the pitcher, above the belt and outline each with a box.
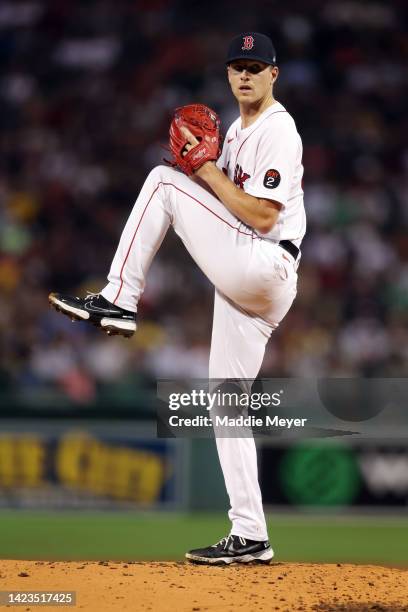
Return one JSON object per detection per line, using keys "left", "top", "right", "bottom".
{"left": 217, "top": 102, "right": 306, "bottom": 247}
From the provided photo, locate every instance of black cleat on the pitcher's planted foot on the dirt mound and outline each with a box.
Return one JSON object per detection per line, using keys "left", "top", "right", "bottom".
{"left": 186, "top": 535, "right": 273, "bottom": 565}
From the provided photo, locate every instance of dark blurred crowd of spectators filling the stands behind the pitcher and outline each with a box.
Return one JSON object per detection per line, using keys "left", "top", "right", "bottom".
{"left": 0, "top": 0, "right": 408, "bottom": 403}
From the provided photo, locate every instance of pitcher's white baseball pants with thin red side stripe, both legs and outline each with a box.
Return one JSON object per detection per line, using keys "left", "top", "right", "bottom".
{"left": 101, "top": 166, "right": 297, "bottom": 540}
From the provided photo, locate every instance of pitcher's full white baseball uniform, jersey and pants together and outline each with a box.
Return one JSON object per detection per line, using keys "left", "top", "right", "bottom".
{"left": 101, "top": 102, "right": 306, "bottom": 540}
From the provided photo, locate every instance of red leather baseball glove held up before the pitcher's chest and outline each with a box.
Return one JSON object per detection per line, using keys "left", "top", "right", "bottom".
{"left": 169, "top": 104, "right": 221, "bottom": 176}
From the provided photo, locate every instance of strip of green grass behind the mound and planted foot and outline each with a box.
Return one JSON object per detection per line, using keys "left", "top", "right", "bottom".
{"left": 0, "top": 511, "right": 408, "bottom": 565}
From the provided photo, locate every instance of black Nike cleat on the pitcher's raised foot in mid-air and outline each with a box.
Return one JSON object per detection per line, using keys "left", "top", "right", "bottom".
{"left": 48, "top": 293, "right": 136, "bottom": 338}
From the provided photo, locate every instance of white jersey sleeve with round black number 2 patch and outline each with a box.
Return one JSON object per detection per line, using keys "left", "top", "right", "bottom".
{"left": 245, "top": 121, "right": 300, "bottom": 206}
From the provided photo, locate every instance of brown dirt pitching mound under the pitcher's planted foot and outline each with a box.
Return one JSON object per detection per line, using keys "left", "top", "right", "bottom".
{"left": 0, "top": 561, "right": 408, "bottom": 612}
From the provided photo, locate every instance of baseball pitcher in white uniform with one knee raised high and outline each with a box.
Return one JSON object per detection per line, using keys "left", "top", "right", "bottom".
{"left": 49, "top": 32, "right": 306, "bottom": 564}
